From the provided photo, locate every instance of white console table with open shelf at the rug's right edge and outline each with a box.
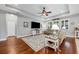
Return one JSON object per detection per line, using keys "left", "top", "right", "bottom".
{"left": 45, "top": 35, "right": 59, "bottom": 52}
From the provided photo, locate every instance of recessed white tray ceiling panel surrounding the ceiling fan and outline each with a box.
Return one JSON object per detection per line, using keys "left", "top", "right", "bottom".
{"left": 18, "top": 4, "right": 68, "bottom": 18}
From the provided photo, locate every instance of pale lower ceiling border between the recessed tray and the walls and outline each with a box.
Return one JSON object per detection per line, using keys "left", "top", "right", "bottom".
{"left": 0, "top": 4, "right": 79, "bottom": 21}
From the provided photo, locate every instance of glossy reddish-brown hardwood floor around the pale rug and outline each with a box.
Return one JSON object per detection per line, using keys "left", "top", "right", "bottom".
{"left": 0, "top": 38, "right": 77, "bottom": 54}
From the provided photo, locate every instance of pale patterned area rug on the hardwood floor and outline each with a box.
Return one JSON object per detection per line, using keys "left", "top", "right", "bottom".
{"left": 22, "top": 35, "right": 45, "bottom": 52}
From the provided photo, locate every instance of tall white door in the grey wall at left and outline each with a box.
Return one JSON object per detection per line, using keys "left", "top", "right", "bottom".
{"left": 6, "top": 14, "right": 17, "bottom": 36}
